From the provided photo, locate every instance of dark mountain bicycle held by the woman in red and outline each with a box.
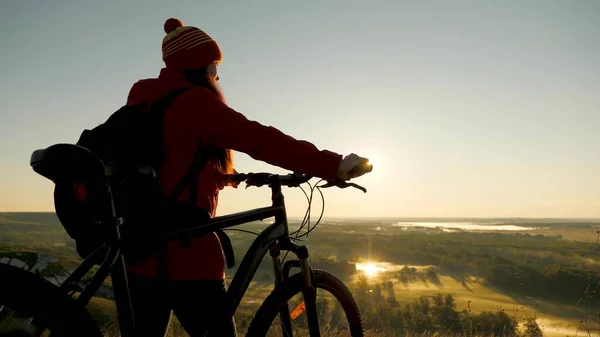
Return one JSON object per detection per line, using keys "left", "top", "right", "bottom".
{"left": 0, "top": 144, "right": 368, "bottom": 337}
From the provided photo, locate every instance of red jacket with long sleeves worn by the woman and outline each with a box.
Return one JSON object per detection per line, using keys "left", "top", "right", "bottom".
{"left": 127, "top": 68, "right": 342, "bottom": 279}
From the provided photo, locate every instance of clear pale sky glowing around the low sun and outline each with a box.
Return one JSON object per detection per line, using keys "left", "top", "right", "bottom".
{"left": 0, "top": 0, "right": 600, "bottom": 217}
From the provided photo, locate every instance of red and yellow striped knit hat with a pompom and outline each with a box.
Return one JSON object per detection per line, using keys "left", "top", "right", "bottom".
{"left": 162, "top": 18, "right": 223, "bottom": 70}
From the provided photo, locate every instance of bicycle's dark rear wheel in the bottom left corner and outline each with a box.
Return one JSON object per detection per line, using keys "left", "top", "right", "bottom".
{"left": 0, "top": 264, "right": 102, "bottom": 337}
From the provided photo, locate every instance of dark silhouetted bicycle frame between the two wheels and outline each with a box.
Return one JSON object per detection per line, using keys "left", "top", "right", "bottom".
{"left": 55, "top": 177, "right": 319, "bottom": 337}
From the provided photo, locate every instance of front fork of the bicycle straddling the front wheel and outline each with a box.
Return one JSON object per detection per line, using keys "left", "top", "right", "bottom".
{"left": 270, "top": 241, "right": 321, "bottom": 337}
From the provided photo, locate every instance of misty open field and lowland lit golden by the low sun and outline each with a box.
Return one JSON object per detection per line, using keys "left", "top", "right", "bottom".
{"left": 0, "top": 213, "right": 600, "bottom": 336}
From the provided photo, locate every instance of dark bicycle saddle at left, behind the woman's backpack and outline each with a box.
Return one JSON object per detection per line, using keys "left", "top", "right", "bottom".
{"left": 29, "top": 144, "right": 109, "bottom": 182}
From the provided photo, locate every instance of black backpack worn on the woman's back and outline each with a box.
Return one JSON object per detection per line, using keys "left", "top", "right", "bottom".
{"left": 54, "top": 89, "right": 209, "bottom": 263}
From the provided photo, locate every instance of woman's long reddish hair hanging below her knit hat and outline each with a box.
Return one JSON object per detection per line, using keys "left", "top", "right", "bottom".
{"left": 183, "top": 68, "right": 233, "bottom": 174}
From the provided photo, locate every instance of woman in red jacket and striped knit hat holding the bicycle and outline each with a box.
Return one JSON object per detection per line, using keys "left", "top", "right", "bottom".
{"left": 127, "top": 19, "right": 367, "bottom": 337}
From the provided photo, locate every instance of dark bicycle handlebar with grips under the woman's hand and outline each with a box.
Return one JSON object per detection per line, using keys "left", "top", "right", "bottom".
{"left": 228, "top": 172, "right": 367, "bottom": 193}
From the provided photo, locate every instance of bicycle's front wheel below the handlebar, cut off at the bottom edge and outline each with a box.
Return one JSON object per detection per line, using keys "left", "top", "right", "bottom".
{"left": 246, "top": 269, "right": 364, "bottom": 337}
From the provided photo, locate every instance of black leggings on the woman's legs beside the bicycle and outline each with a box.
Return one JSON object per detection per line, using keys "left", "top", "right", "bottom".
{"left": 127, "top": 273, "right": 237, "bottom": 337}
